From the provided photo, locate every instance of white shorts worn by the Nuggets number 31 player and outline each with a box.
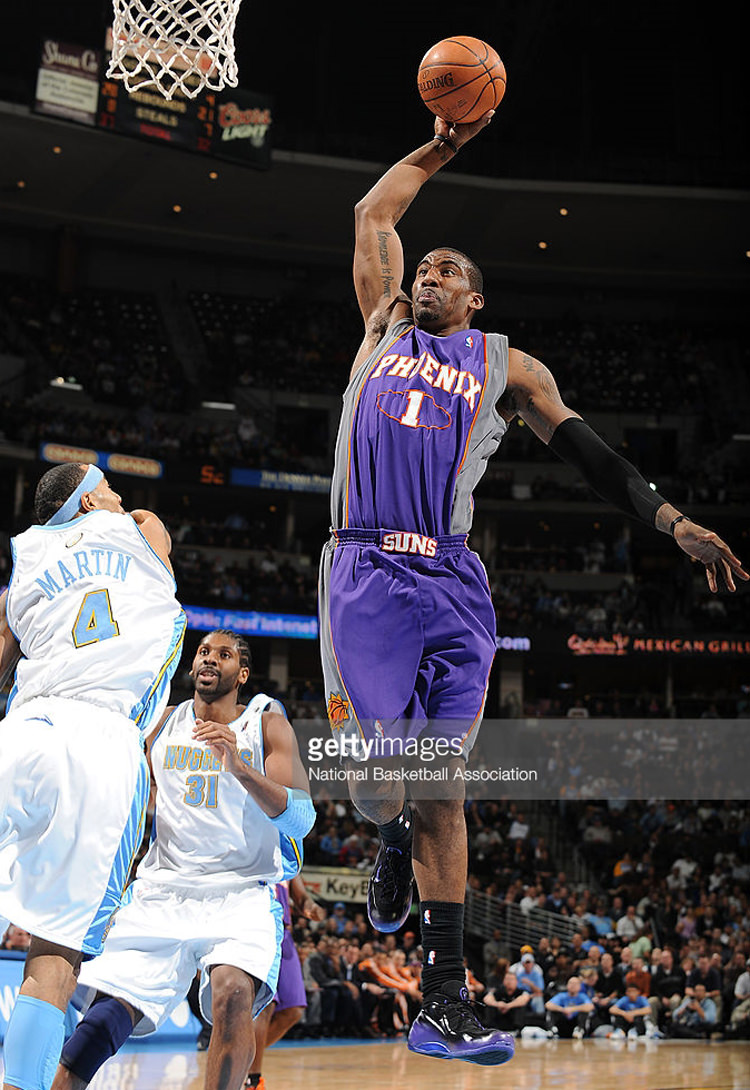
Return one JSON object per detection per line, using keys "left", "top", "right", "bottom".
{"left": 78, "top": 875, "right": 283, "bottom": 1037}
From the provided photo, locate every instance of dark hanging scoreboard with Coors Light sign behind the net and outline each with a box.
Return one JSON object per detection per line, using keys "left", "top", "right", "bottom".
{"left": 34, "top": 38, "right": 273, "bottom": 170}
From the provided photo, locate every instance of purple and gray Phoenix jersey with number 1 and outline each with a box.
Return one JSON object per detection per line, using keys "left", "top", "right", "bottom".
{"left": 330, "top": 319, "right": 508, "bottom": 537}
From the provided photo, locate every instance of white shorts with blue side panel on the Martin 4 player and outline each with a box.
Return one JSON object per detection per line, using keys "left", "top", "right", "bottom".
{"left": 0, "top": 697, "right": 148, "bottom": 956}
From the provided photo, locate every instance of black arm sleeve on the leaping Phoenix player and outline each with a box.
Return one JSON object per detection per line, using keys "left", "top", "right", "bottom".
{"left": 549, "top": 416, "right": 668, "bottom": 526}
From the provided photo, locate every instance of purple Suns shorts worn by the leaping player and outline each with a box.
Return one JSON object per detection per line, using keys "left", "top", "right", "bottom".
{"left": 319, "top": 530, "right": 495, "bottom": 755}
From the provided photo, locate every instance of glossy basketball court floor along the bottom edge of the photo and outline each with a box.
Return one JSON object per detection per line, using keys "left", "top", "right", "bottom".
{"left": 5, "top": 1040, "right": 750, "bottom": 1090}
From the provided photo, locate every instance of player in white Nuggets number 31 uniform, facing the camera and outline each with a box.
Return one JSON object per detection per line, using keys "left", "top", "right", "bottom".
{"left": 53, "top": 629, "right": 315, "bottom": 1090}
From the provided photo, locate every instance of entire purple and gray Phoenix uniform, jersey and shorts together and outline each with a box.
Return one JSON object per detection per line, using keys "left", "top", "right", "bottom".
{"left": 318, "top": 319, "right": 508, "bottom": 755}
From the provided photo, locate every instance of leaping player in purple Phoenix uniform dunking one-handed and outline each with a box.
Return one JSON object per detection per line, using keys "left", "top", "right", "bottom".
{"left": 319, "top": 112, "right": 750, "bottom": 1064}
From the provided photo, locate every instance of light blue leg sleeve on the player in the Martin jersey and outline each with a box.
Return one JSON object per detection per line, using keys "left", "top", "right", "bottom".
{"left": 2, "top": 995, "right": 65, "bottom": 1090}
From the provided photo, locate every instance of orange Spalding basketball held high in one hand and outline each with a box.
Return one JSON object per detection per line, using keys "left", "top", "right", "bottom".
{"left": 416, "top": 38, "right": 506, "bottom": 124}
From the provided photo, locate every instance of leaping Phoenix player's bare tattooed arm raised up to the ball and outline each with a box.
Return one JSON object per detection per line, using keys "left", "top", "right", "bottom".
{"left": 352, "top": 110, "right": 494, "bottom": 373}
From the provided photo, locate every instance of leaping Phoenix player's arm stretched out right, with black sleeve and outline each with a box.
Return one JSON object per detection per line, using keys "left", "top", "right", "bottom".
{"left": 498, "top": 349, "right": 750, "bottom": 592}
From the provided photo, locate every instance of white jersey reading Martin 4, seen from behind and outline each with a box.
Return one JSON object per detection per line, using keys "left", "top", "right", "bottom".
{"left": 7, "top": 510, "right": 185, "bottom": 730}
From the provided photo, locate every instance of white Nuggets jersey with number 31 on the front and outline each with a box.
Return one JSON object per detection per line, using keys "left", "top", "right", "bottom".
{"left": 137, "top": 693, "right": 302, "bottom": 889}
